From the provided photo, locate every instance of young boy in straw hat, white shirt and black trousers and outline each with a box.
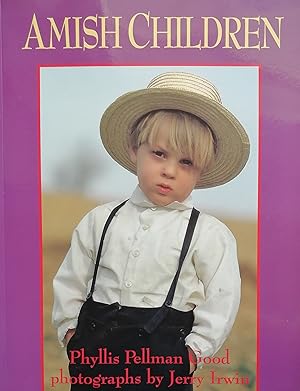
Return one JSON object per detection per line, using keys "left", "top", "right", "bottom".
{"left": 53, "top": 72, "right": 249, "bottom": 390}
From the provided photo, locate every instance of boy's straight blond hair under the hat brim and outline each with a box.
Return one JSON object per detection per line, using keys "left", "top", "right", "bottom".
{"left": 129, "top": 110, "right": 216, "bottom": 172}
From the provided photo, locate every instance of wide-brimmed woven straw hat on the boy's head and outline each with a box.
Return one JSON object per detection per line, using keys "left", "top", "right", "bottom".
{"left": 100, "top": 72, "right": 250, "bottom": 189}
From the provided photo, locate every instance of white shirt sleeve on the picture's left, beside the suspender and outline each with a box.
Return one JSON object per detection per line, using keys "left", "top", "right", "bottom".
{"left": 52, "top": 208, "right": 95, "bottom": 345}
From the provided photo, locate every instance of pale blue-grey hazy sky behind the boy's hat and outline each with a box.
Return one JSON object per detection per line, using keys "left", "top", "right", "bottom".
{"left": 40, "top": 66, "right": 259, "bottom": 220}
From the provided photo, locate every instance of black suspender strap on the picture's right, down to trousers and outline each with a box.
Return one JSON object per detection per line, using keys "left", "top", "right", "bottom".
{"left": 144, "top": 208, "right": 199, "bottom": 334}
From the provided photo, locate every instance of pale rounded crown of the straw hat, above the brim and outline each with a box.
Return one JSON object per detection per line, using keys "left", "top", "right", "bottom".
{"left": 147, "top": 72, "right": 222, "bottom": 104}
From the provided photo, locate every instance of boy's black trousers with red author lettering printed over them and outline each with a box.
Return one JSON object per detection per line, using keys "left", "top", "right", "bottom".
{"left": 67, "top": 298, "right": 193, "bottom": 391}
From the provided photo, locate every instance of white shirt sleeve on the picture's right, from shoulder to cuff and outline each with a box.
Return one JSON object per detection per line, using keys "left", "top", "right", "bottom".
{"left": 186, "top": 220, "right": 241, "bottom": 357}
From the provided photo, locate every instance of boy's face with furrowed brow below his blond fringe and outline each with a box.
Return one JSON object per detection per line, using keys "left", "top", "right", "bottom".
{"left": 130, "top": 132, "right": 200, "bottom": 206}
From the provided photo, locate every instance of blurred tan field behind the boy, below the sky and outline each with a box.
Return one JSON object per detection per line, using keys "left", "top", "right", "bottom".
{"left": 42, "top": 193, "right": 257, "bottom": 391}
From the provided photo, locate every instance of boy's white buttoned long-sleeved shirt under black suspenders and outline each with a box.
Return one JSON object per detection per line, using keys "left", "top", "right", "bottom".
{"left": 53, "top": 187, "right": 240, "bottom": 357}
